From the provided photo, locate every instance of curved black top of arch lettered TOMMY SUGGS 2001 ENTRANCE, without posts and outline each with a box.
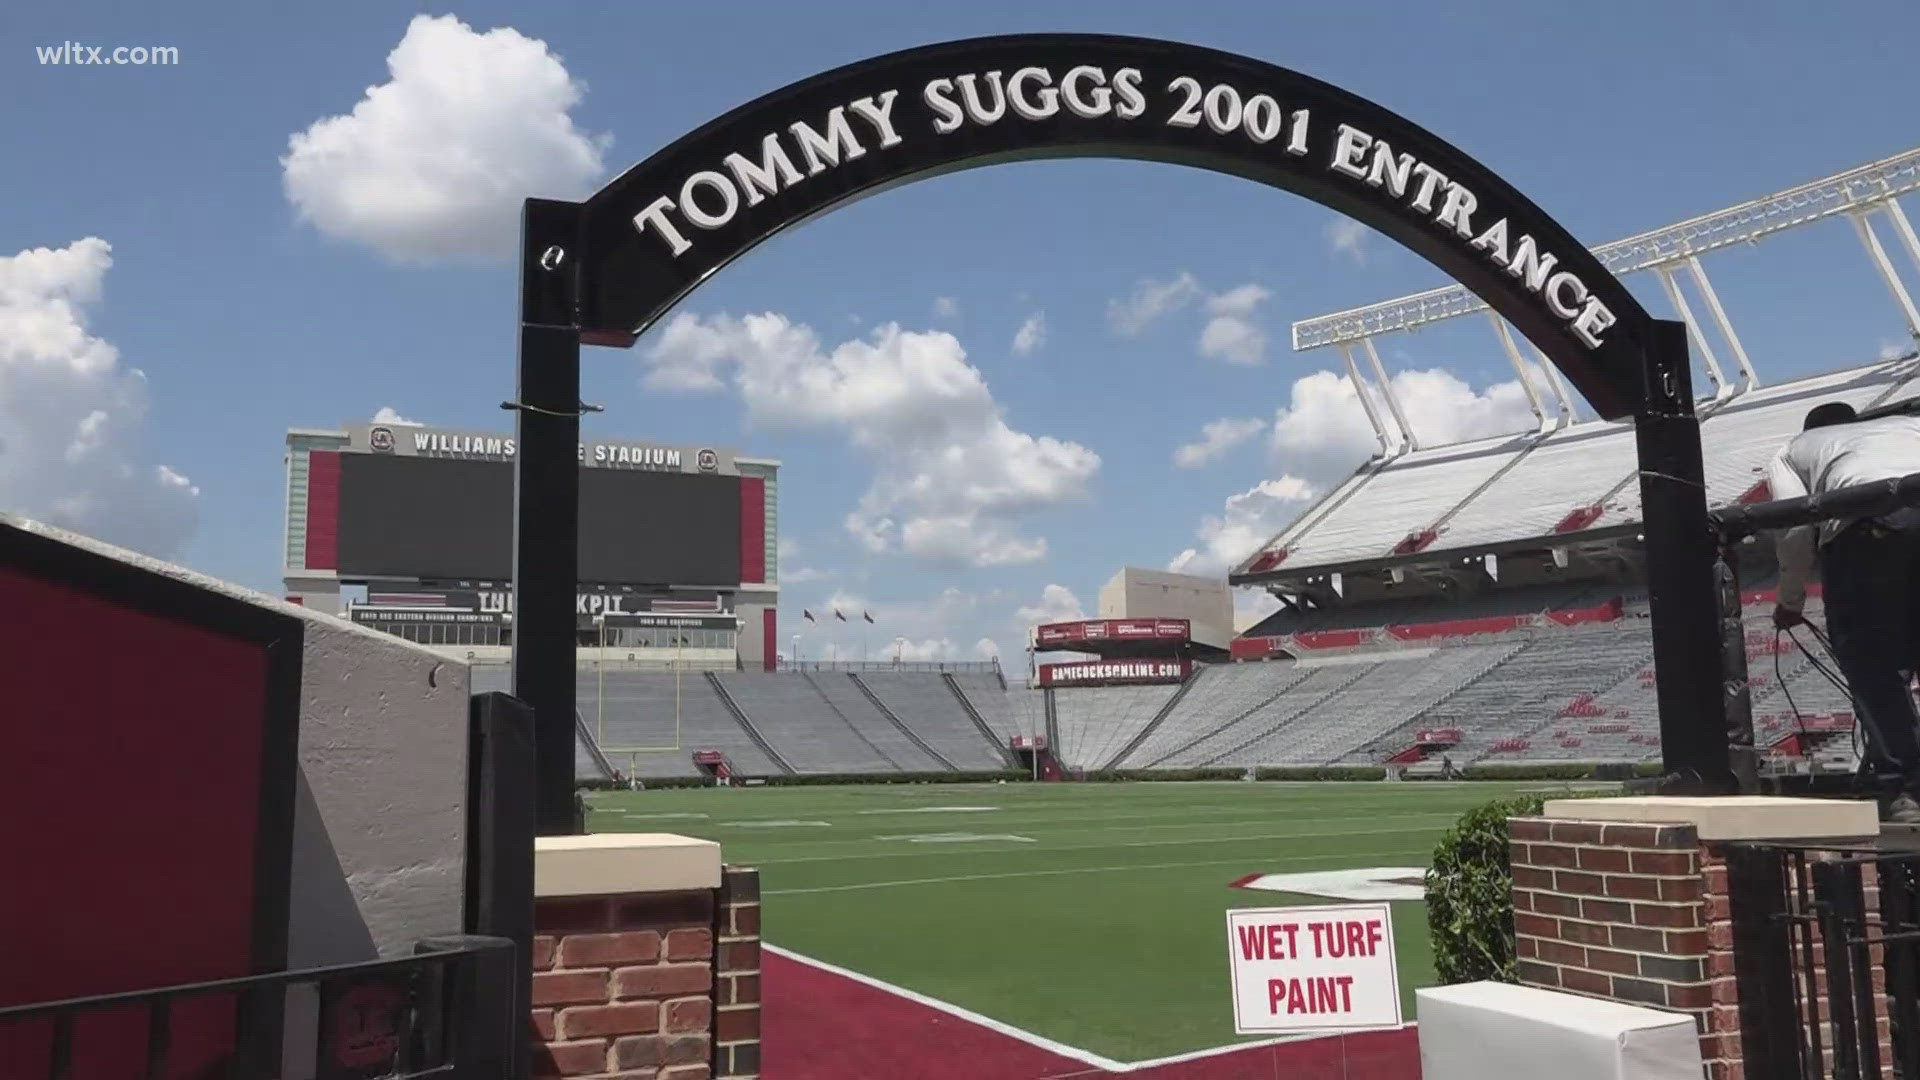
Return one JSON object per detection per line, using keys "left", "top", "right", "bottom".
{"left": 580, "top": 35, "right": 1649, "bottom": 417}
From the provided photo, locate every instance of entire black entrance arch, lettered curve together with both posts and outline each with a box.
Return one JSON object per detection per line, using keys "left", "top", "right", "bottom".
{"left": 511, "top": 35, "right": 1724, "bottom": 813}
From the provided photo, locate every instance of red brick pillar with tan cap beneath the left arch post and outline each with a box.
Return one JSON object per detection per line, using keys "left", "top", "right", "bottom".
{"left": 532, "top": 834, "right": 725, "bottom": 1080}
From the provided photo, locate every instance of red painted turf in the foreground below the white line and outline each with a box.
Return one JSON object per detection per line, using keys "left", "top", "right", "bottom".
{"left": 760, "top": 951, "right": 1421, "bottom": 1080}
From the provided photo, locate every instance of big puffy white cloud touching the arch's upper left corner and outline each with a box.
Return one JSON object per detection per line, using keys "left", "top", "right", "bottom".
{"left": 280, "top": 15, "right": 609, "bottom": 261}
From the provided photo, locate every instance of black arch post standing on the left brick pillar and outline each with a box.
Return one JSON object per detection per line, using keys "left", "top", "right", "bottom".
{"left": 509, "top": 198, "right": 580, "bottom": 836}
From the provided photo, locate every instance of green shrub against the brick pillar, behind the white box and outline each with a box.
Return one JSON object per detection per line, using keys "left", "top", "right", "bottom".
{"left": 1427, "top": 796, "right": 1544, "bottom": 984}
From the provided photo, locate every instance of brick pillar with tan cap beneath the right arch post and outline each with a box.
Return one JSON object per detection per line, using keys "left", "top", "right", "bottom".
{"left": 1509, "top": 798, "right": 1891, "bottom": 1080}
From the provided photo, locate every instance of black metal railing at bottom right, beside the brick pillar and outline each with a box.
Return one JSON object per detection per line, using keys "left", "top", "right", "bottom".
{"left": 1728, "top": 844, "right": 1920, "bottom": 1080}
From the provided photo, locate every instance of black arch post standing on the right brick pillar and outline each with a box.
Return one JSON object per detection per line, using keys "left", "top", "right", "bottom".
{"left": 1634, "top": 321, "right": 1740, "bottom": 794}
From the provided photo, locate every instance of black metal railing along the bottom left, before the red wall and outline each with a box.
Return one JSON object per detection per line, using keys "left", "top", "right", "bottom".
{"left": 0, "top": 936, "right": 524, "bottom": 1080}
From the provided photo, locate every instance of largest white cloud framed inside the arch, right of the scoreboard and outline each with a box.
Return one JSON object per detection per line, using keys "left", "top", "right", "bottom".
{"left": 643, "top": 313, "right": 1100, "bottom": 567}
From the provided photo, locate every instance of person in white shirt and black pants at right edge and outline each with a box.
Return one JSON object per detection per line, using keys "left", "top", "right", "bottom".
{"left": 1766, "top": 402, "right": 1920, "bottom": 821}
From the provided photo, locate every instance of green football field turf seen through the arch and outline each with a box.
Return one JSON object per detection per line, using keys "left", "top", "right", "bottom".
{"left": 589, "top": 782, "right": 1589, "bottom": 1061}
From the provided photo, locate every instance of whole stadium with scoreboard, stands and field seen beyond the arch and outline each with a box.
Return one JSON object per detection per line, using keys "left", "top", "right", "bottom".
{"left": 266, "top": 152, "right": 1920, "bottom": 1076}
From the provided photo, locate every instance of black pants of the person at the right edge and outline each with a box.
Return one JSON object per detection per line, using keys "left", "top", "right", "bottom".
{"left": 1820, "top": 509, "right": 1920, "bottom": 794}
